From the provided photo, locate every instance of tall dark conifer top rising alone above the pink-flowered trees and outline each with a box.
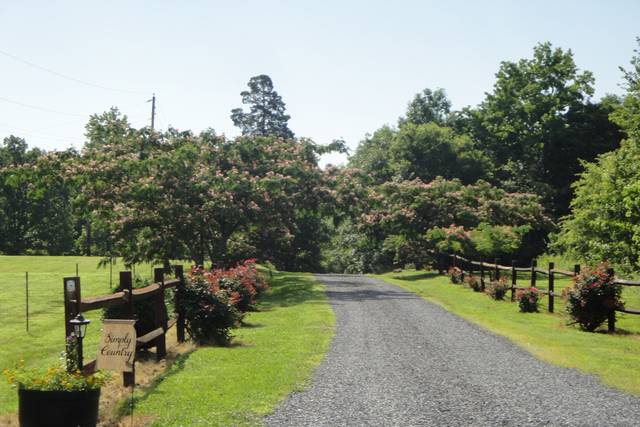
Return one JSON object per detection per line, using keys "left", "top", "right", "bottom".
{"left": 231, "top": 74, "right": 293, "bottom": 138}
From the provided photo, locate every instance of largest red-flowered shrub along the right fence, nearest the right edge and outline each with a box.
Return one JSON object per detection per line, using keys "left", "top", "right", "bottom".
{"left": 565, "top": 264, "right": 624, "bottom": 332}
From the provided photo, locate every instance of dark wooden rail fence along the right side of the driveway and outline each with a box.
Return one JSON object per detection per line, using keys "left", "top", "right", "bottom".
{"left": 445, "top": 254, "right": 640, "bottom": 332}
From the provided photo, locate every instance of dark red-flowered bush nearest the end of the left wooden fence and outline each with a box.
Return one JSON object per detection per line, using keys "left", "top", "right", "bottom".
{"left": 181, "top": 268, "right": 242, "bottom": 345}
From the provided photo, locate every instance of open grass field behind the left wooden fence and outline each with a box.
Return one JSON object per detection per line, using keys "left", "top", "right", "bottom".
{"left": 0, "top": 256, "right": 174, "bottom": 414}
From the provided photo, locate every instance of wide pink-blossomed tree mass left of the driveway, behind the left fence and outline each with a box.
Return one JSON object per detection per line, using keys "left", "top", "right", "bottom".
{"left": 74, "top": 110, "right": 338, "bottom": 270}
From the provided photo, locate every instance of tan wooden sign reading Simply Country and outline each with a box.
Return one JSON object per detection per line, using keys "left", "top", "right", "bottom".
{"left": 96, "top": 319, "right": 136, "bottom": 372}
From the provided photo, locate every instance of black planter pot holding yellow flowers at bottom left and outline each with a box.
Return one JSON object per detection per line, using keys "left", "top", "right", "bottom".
{"left": 18, "top": 389, "right": 100, "bottom": 427}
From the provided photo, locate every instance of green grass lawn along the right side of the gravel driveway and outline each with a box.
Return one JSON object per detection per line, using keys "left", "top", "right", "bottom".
{"left": 376, "top": 271, "right": 640, "bottom": 394}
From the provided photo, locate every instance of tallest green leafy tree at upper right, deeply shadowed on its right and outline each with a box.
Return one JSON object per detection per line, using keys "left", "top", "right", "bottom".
{"left": 457, "top": 43, "right": 620, "bottom": 215}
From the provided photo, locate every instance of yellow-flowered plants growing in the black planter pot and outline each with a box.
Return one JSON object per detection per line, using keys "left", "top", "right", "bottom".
{"left": 2, "top": 360, "right": 110, "bottom": 391}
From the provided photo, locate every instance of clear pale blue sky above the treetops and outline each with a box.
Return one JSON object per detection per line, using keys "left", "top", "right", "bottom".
{"left": 0, "top": 0, "right": 640, "bottom": 166}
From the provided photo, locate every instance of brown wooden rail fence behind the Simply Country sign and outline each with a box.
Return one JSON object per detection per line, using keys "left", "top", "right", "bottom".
{"left": 64, "top": 265, "right": 185, "bottom": 386}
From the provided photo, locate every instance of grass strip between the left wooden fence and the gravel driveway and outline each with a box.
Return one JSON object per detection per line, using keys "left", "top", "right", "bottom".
{"left": 127, "top": 273, "right": 334, "bottom": 426}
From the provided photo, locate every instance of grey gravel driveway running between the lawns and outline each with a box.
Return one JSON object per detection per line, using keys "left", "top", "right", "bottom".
{"left": 264, "top": 275, "right": 640, "bottom": 426}
